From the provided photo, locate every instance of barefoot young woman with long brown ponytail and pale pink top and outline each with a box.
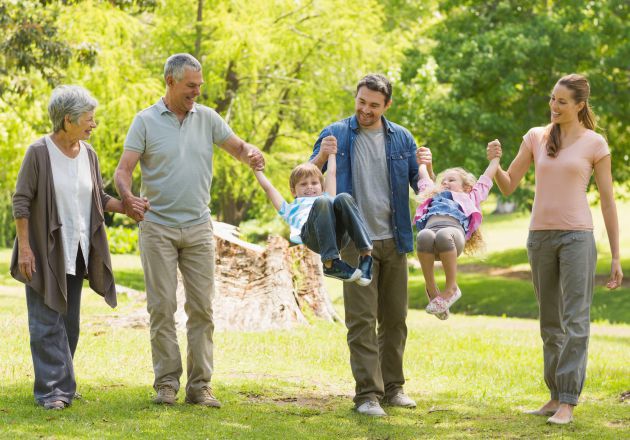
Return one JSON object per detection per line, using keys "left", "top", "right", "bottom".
{"left": 487, "top": 74, "right": 623, "bottom": 424}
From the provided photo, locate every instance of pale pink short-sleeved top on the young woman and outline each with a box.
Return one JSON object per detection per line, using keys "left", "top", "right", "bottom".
{"left": 523, "top": 127, "right": 610, "bottom": 231}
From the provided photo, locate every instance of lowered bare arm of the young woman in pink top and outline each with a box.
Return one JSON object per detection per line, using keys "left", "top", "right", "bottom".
{"left": 595, "top": 155, "right": 623, "bottom": 289}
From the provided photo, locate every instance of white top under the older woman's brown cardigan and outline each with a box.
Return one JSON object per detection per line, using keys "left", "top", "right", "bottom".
{"left": 46, "top": 136, "right": 92, "bottom": 275}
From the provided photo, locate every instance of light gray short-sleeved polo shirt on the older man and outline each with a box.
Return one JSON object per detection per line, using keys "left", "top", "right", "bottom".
{"left": 124, "top": 98, "right": 232, "bottom": 228}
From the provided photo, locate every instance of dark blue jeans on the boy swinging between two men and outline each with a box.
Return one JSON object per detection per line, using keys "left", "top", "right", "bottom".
{"left": 300, "top": 193, "right": 372, "bottom": 261}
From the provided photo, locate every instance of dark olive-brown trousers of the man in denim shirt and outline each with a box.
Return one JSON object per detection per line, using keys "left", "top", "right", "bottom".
{"left": 341, "top": 239, "right": 407, "bottom": 406}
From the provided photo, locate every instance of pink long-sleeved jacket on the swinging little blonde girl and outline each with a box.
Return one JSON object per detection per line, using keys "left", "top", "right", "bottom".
{"left": 413, "top": 175, "right": 492, "bottom": 240}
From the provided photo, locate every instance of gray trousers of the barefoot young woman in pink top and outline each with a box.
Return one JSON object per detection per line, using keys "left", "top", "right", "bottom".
{"left": 527, "top": 231, "right": 597, "bottom": 405}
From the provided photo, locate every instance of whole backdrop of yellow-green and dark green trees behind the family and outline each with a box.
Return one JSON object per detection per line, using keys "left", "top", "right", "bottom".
{"left": 0, "top": 0, "right": 630, "bottom": 245}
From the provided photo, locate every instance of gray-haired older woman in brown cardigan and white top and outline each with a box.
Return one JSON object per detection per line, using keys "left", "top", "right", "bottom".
{"left": 11, "top": 86, "right": 145, "bottom": 409}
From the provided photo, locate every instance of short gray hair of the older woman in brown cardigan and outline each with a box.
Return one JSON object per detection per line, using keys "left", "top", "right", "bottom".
{"left": 48, "top": 86, "right": 98, "bottom": 133}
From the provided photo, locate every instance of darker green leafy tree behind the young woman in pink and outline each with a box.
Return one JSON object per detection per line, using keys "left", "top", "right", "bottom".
{"left": 402, "top": 0, "right": 630, "bottom": 206}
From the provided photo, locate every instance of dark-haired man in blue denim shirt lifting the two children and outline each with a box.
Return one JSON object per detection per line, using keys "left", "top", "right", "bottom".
{"left": 311, "top": 74, "right": 418, "bottom": 416}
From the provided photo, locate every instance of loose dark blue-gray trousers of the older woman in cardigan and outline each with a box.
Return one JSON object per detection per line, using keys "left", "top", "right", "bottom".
{"left": 26, "top": 249, "right": 85, "bottom": 405}
